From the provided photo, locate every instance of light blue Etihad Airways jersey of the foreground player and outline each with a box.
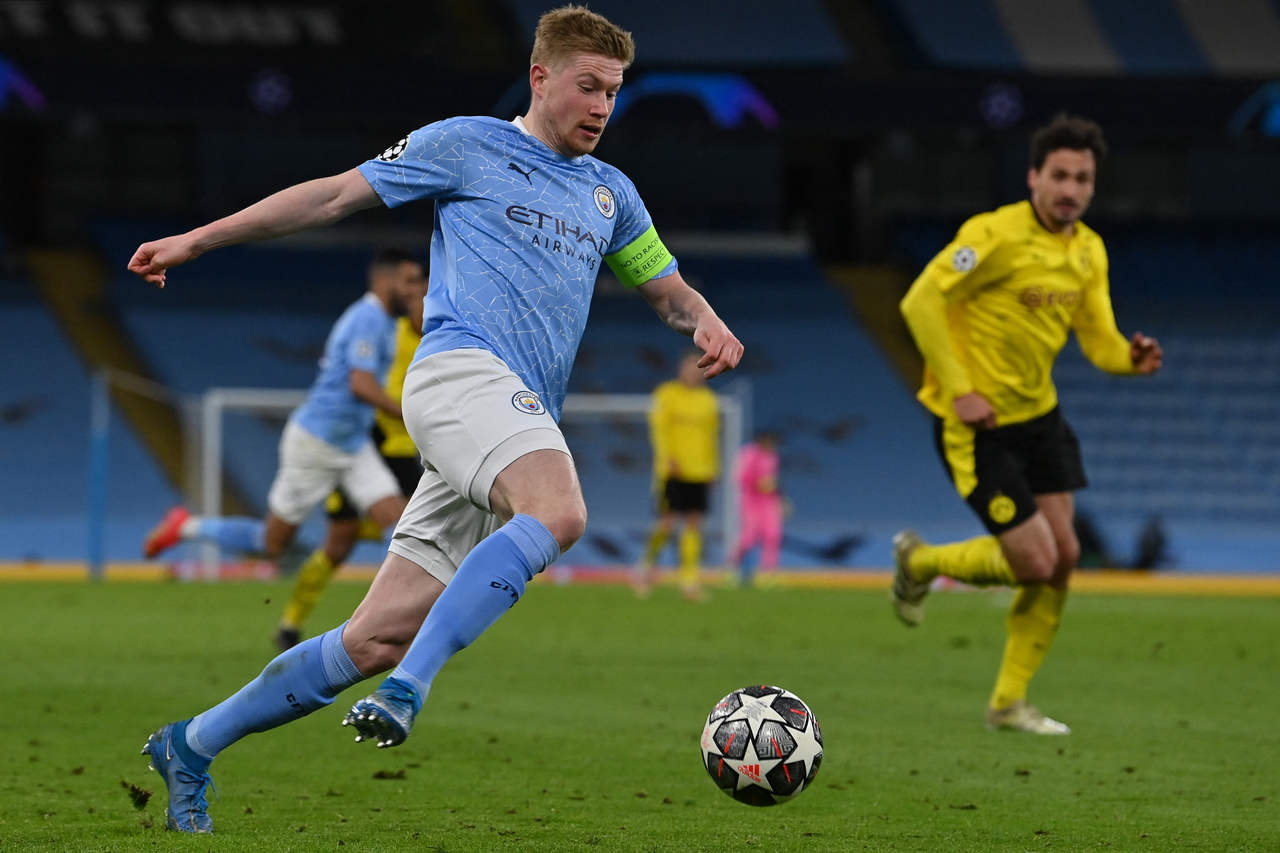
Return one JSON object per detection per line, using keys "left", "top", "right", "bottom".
{"left": 358, "top": 117, "right": 677, "bottom": 420}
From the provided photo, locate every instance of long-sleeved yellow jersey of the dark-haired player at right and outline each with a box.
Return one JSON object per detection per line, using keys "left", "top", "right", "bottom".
{"left": 901, "top": 201, "right": 1134, "bottom": 425}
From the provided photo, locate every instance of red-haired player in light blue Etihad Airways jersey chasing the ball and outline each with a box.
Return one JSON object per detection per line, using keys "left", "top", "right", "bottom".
{"left": 129, "top": 6, "right": 742, "bottom": 831}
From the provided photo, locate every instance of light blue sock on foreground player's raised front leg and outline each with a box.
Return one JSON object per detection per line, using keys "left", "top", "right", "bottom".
{"left": 388, "top": 515, "right": 559, "bottom": 706}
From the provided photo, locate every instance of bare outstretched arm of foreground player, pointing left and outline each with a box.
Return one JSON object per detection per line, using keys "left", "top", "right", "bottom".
{"left": 129, "top": 169, "right": 380, "bottom": 287}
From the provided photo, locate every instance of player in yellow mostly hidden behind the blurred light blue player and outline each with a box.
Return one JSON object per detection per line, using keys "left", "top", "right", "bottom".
{"left": 275, "top": 254, "right": 426, "bottom": 652}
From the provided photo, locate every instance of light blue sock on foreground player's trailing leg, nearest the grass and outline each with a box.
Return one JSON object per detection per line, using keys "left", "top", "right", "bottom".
{"left": 183, "top": 614, "right": 365, "bottom": 758}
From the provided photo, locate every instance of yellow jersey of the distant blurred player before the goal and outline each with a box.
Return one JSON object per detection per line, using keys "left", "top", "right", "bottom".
{"left": 649, "top": 379, "right": 719, "bottom": 483}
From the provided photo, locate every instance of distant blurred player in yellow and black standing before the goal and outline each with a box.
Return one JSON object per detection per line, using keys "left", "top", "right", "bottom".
{"left": 636, "top": 352, "right": 719, "bottom": 601}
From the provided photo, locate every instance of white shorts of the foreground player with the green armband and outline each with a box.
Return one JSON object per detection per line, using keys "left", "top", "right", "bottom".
{"left": 390, "top": 350, "right": 570, "bottom": 584}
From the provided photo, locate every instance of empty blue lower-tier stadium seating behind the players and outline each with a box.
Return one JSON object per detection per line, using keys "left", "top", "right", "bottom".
{"left": 52, "top": 213, "right": 1280, "bottom": 569}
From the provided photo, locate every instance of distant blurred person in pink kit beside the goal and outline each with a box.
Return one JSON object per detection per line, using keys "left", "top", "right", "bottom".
{"left": 732, "top": 432, "right": 782, "bottom": 587}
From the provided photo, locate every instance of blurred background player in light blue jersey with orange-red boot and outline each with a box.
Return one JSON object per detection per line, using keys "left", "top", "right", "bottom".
{"left": 142, "top": 248, "right": 426, "bottom": 573}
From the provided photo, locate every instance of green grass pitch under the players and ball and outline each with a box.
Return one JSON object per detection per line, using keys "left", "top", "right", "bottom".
{"left": 0, "top": 573, "right": 1280, "bottom": 853}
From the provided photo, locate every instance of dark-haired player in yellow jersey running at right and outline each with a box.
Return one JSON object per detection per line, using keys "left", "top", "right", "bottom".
{"left": 893, "top": 114, "right": 1164, "bottom": 734}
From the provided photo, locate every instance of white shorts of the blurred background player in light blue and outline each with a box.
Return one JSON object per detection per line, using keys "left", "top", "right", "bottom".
{"left": 266, "top": 419, "right": 401, "bottom": 524}
